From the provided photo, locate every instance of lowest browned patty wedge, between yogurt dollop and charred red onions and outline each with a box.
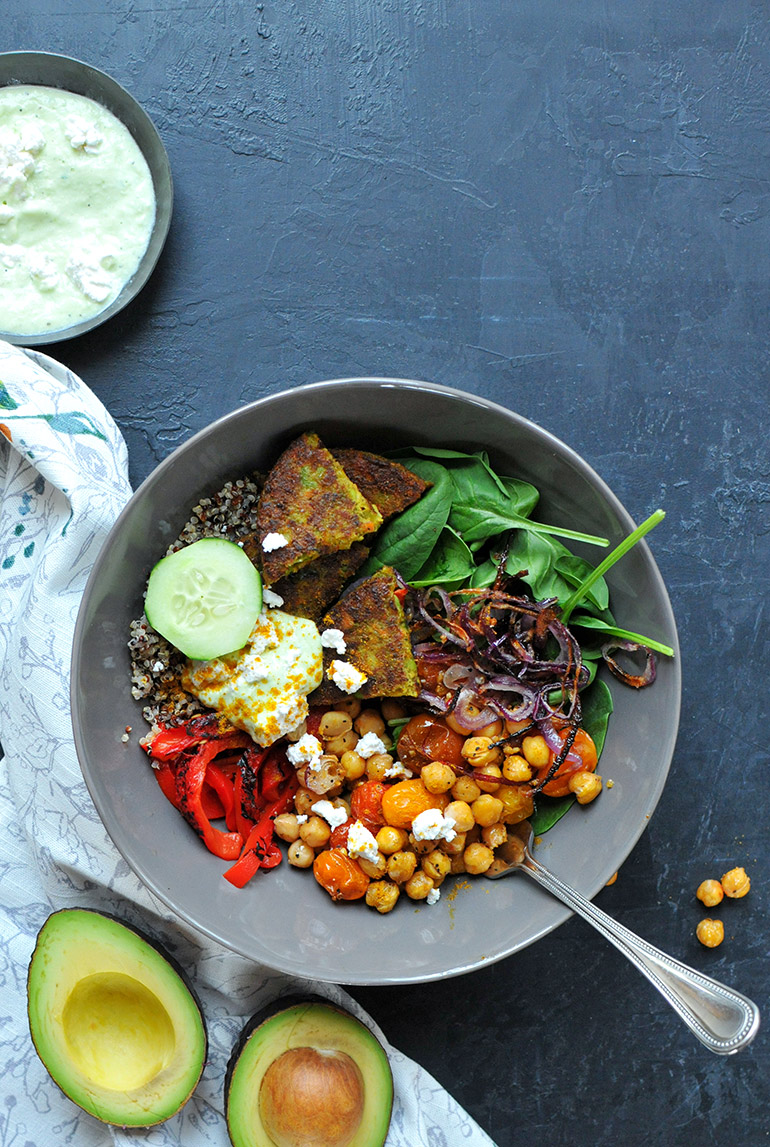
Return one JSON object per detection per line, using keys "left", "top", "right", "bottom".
{"left": 310, "top": 565, "right": 420, "bottom": 704}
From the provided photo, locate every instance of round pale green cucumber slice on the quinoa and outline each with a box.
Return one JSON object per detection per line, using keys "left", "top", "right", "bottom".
{"left": 145, "top": 538, "right": 262, "bottom": 661}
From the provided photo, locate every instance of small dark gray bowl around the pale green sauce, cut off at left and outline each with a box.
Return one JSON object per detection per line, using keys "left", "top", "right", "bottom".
{"left": 0, "top": 52, "right": 173, "bottom": 346}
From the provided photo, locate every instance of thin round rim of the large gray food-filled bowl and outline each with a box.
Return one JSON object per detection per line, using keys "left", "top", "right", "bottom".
{"left": 70, "top": 375, "right": 682, "bottom": 986}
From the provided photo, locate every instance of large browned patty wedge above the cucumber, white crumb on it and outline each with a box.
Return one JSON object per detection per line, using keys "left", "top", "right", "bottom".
{"left": 252, "top": 432, "right": 382, "bottom": 586}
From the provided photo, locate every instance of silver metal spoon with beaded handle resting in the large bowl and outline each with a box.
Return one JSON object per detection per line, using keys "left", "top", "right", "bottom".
{"left": 487, "top": 822, "right": 760, "bottom": 1055}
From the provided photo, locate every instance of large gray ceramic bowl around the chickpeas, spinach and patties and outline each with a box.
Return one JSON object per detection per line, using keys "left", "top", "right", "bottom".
{"left": 71, "top": 379, "right": 680, "bottom": 984}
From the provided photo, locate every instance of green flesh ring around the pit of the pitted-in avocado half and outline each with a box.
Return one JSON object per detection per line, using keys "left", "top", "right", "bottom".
{"left": 225, "top": 1001, "right": 392, "bottom": 1147}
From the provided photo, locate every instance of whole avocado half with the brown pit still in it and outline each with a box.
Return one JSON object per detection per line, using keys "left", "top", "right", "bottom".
{"left": 225, "top": 999, "right": 392, "bottom": 1147}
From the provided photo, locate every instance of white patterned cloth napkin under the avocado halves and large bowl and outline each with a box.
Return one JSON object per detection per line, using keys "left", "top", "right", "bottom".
{"left": 0, "top": 342, "right": 493, "bottom": 1147}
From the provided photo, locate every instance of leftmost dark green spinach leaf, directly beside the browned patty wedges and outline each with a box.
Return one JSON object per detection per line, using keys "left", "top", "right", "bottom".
{"left": 360, "top": 459, "right": 452, "bottom": 582}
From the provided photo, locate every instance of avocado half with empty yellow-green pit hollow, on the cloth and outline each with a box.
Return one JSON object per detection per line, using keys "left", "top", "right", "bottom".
{"left": 28, "top": 908, "right": 207, "bottom": 1126}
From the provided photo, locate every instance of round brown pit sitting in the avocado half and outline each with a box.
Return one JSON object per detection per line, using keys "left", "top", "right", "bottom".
{"left": 259, "top": 1047, "right": 364, "bottom": 1147}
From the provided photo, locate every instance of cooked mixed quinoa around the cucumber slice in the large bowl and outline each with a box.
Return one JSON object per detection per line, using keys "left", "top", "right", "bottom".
{"left": 129, "top": 473, "right": 262, "bottom": 728}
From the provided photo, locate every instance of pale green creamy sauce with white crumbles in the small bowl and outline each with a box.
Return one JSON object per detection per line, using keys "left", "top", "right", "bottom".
{"left": 0, "top": 85, "right": 155, "bottom": 335}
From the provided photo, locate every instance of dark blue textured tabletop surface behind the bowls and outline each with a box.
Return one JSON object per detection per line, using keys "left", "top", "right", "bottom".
{"left": 0, "top": 0, "right": 770, "bottom": 1147}
